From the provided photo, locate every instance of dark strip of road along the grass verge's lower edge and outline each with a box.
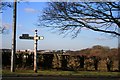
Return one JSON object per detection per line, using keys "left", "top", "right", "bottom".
{"left": 2, "top": 76, "right": 120, "bottom": 80}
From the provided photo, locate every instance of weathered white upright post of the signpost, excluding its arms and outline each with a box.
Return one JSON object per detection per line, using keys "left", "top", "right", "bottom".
{"left": 34, "top": 30, "right": 38, "bottom": 73}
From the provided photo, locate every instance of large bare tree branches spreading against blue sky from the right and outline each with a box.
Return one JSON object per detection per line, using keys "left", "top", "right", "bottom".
{"left": 38, "top": 2, "right": 120, "bottom": 71}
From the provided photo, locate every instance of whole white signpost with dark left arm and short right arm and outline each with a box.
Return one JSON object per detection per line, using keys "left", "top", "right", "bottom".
{"left": 19, "top": 30, "right": 44, "bottom": 72}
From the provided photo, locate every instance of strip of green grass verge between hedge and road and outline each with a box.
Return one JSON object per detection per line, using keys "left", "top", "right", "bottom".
{"left": 2, "top": 70, "right": 120, "bottom": 76}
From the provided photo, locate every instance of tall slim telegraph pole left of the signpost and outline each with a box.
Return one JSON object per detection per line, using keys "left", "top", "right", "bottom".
{"left": 11, "top": 0, "right": 17, "bottom": 72}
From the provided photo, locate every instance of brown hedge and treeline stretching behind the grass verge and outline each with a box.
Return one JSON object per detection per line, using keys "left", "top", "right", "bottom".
{"left": 2, "top": 45, "right": 118, "bottom": 71}
